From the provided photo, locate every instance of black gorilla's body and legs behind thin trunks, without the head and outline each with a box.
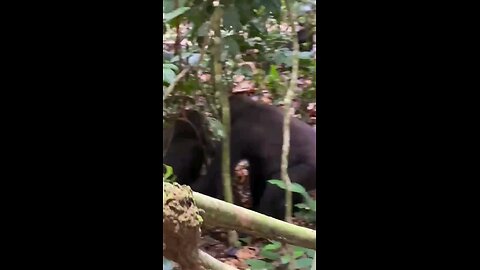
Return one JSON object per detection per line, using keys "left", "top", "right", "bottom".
{"left": 191, "top": 95, "right": 316, "bottom": 219}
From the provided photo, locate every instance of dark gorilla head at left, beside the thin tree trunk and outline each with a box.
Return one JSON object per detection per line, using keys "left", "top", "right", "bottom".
{"left": 163, "top": 110, "right": 213, "bottom": 185}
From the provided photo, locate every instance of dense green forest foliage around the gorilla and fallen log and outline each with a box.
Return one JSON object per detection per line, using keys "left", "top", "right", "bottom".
{"left": 163, "top": 0, "right": 316, "bottom": 269}
